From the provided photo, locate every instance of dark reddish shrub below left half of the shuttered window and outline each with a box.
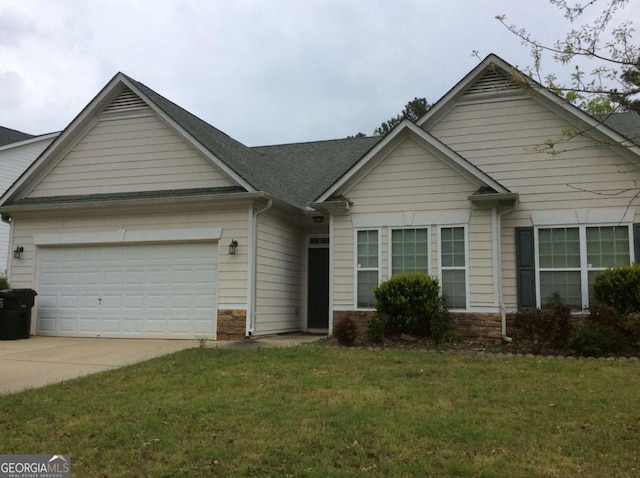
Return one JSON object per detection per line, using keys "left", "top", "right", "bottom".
{"left": 513, "top": 300, "right": 571, "bottom": 354}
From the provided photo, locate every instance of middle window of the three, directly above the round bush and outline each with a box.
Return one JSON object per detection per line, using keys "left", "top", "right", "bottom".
{"left": 391, "top": 228, "right": 429, "bottom": 275}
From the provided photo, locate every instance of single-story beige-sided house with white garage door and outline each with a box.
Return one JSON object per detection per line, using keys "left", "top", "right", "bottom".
{"left": 0, "top": 55, "right": 640, "bottom": 339}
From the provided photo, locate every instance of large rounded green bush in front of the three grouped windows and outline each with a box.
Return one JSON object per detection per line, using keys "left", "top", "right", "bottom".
{"left": 375, "top": 272, "right": 450, "bottom": 338}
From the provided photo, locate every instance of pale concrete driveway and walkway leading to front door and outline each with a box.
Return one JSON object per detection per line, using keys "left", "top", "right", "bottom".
{"left": 0, "top": 334, "right": 321, "bottom": 395}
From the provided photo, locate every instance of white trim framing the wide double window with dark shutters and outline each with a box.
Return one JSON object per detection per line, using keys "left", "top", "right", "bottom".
{"left": 534, "top": 222, "right": 634, "bottom": 310}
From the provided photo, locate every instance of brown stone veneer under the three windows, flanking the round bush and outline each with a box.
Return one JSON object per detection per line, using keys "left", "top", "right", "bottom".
{"left": 333, "top": 310, "right": 502, "bottom": 343}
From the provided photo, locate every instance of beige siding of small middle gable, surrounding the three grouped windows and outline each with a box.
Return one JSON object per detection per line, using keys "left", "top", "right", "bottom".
{"left": 333, "top": 139, "right": 495, "bottom": 310}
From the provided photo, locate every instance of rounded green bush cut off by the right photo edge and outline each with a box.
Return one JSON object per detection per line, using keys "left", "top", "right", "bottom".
{"left": 593, "top": 263, "right": 640, "bottom": 314}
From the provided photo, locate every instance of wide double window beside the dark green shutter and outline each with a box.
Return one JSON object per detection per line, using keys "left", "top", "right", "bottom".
{"left": 537, "top": 225, "right": 631, "bottom": 310}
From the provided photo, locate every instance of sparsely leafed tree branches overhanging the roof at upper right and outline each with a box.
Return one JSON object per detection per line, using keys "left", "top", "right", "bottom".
{"left": 496, "top": 0, "right": 640, "bottom": 115}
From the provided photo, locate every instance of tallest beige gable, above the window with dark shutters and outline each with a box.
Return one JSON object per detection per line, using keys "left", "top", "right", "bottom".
{"left": 417, "top": 55, "right": 640, "bottom": 209}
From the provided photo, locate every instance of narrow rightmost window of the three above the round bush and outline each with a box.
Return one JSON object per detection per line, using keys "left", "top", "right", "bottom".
{"left": 440, "top": 226, "right": 467, "bottom": 309}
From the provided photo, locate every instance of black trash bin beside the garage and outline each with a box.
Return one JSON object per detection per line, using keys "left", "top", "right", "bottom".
{"left": 0, "top": 289, "right": 38, "bottom": 340}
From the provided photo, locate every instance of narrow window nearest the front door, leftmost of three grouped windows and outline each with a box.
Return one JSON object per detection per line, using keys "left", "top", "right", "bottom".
{"left": 356, "top": 229, "right": 380, "bottom": 309}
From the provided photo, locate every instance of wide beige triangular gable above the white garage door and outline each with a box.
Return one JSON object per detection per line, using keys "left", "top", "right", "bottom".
{"left": 3, "top": 74, "right": 253, "bottom": 204}
